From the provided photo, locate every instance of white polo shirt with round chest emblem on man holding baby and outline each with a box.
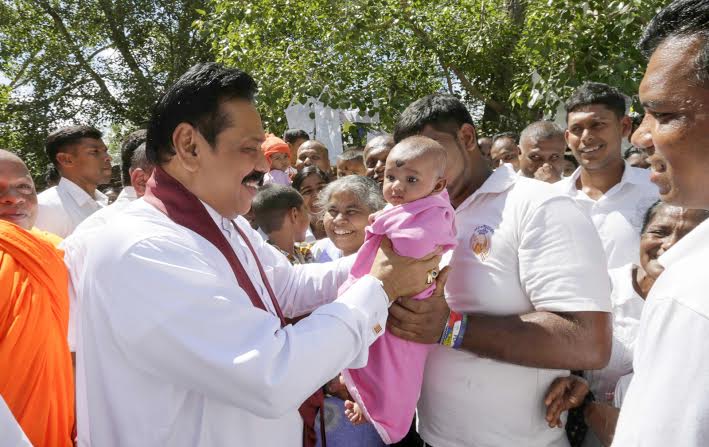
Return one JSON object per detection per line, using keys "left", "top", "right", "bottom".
{"left": 418, "top": 166, "right": 610, "bottom": 447}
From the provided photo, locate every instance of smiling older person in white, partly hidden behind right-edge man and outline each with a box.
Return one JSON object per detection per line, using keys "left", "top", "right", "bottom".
{"left": 545, "top": 201, "right": 709, "bottom": 446}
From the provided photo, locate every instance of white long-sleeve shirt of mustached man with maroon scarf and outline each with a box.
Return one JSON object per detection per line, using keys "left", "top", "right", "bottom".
{"left": 75, "top": 200, "right": 388, "bottom": 447}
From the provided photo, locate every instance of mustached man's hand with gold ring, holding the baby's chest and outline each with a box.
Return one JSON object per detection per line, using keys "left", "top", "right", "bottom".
{"left": 370, "top": 238, "right": 441, "bottom": 301}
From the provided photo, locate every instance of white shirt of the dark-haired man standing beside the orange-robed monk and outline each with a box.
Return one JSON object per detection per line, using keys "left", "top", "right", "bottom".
{"left": 35, "top": 177, "right": 108, "bottom": 238}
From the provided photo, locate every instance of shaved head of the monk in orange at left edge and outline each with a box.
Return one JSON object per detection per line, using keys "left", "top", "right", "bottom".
{"left": 0, "top": 149, "right": 37, "bottom": 230}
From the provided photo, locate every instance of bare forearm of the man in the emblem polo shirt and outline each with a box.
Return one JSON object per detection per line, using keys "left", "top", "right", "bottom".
{"left": 462, "top": 312, "right": 611, "bottom": 370}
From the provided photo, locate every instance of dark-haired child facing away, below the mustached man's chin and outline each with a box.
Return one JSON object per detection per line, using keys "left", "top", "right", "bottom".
{"left": 251, "top": 184, "right": 313, "bottom": 265}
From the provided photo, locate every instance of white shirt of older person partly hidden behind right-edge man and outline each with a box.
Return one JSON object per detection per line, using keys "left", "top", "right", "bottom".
{"left": 584, "top": 264, "right": 645, "bottom": 404}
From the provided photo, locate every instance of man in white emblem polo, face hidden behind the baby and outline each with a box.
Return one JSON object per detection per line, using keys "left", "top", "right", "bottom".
{"left": 390, "top": 95, "right": 611, "bottom": 447}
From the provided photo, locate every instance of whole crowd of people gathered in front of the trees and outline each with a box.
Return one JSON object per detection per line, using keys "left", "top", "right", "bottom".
{"left": 0, "top": 0, "right": 709, "bottom": 447}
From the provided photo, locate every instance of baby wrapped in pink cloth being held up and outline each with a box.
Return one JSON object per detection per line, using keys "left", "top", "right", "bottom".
{"left": 340, "top": 136, "right": 456, "bottom": 444}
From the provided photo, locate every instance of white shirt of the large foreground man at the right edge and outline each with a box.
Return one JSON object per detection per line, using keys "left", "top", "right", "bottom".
{"left": 613, "top": 220, "right": 709, "bottom": 447}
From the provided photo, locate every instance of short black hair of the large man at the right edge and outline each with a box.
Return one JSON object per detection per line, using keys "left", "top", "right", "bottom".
{"left": 638, "top": 0, "right": 709, "bottom": 84}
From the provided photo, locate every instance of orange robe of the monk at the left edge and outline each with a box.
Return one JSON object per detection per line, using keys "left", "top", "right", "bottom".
{"left": 0, "top": 220, "right": 74, "bottom": 447}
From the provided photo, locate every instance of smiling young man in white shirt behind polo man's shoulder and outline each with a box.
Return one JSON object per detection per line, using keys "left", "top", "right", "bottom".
{"left": 556, "top": 82, "right": 658, "bottom": 269}
